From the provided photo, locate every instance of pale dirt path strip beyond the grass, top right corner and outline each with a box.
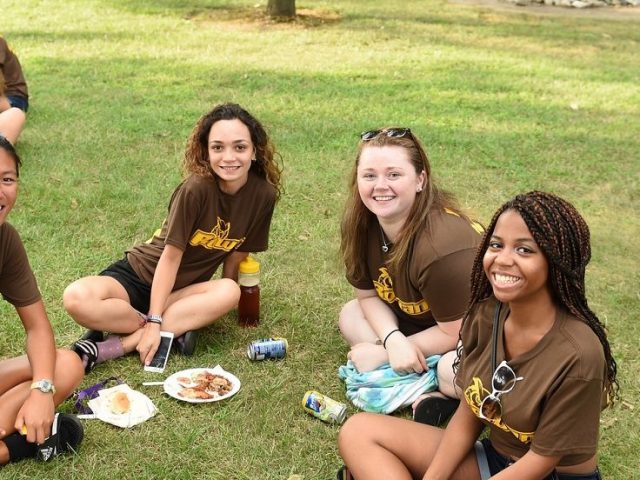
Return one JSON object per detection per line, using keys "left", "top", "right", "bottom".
{"left": 449, "top": 0, "right": 640, "bottom": 22}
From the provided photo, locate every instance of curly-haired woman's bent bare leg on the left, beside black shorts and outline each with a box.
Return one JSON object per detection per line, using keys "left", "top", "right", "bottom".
{"left": 63, "top": 276, "right": 145, "bottom": 334}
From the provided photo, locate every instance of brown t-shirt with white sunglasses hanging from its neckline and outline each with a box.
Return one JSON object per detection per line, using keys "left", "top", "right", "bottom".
{"left": 456, "top": 297, "right": 606, "bottom": 466}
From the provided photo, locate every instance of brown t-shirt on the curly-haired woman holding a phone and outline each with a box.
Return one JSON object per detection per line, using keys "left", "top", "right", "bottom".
{"left": 127, "top": 172, "right": 276, "bottom": 290}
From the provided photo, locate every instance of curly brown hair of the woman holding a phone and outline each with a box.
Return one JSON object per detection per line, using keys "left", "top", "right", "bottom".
{"left": 182, "top": 103, "right": 282, "bottom": 198}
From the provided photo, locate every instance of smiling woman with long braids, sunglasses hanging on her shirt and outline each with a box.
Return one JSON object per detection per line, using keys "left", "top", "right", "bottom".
{"left": 338, "top": 192, "right": 618, "bottom": 480}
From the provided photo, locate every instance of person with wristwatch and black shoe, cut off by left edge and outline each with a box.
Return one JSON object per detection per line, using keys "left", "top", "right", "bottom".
{"left": 0, "top": 135, "right": 83, "bottom": 464}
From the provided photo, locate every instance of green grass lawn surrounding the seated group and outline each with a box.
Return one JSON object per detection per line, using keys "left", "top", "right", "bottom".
{"left": 0, "top": 0, "right": 640, "bottom": 480}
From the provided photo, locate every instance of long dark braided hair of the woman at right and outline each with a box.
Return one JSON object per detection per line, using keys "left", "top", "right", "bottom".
{"left": 458, "top": 191, "right": 619, "bottom": 402}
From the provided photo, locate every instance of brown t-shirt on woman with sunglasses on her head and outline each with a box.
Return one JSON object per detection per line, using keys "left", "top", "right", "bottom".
{"left": 347, "top": 212, "right": 481, "bottom": 335}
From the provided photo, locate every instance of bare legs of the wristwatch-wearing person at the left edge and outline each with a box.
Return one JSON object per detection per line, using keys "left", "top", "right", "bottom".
{"left": 0, "top": 350, "right": 84, "bottom": 446}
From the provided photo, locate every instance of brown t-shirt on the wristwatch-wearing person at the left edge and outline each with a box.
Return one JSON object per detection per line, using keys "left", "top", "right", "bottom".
{"left": 0, "top": 222, "right": 41, "bottom": 307}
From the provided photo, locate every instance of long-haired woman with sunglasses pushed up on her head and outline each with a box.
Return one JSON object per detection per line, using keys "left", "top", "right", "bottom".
{"left": 339, "top": 128, "right": 482, "bottom": 425}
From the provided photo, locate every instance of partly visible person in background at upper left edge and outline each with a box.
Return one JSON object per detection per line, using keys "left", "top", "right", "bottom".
{"left": 0, "top": 37, "right": 29, "bottom": 145}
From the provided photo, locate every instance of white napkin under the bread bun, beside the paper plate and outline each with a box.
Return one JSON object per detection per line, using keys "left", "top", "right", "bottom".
{"left": 89, "top": 383, "right": 158, "bottom": 428}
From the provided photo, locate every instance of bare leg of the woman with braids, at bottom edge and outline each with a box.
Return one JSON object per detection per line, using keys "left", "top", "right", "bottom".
{"left": 338, "top": 413, "right": 480, "bottom": 480}
